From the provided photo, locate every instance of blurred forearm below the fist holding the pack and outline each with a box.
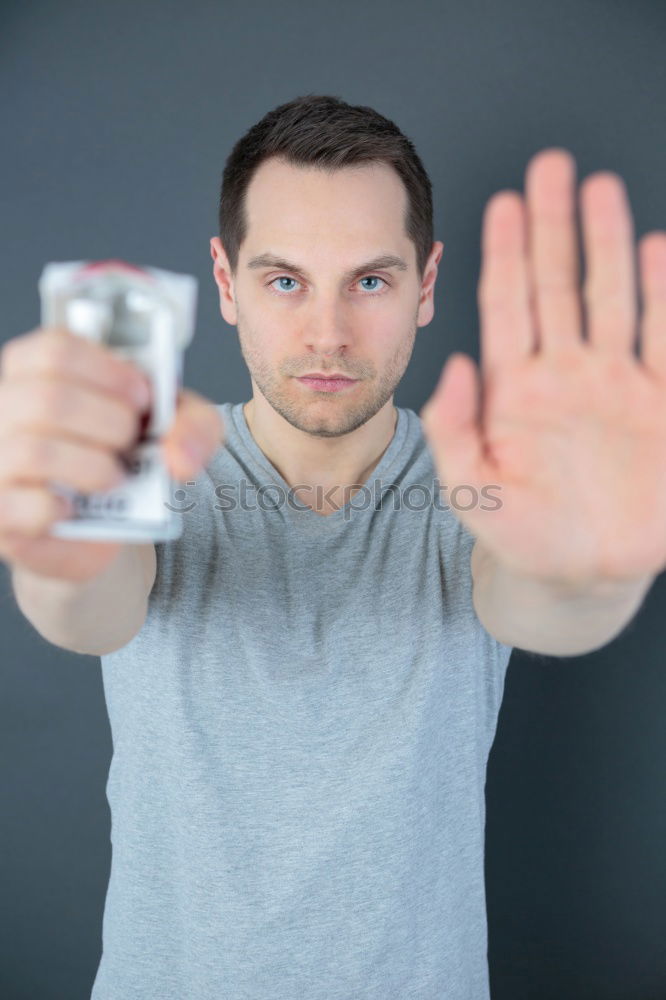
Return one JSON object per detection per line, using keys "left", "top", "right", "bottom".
{"left": 11, "top": 542, "right": 157, "bottom": 656}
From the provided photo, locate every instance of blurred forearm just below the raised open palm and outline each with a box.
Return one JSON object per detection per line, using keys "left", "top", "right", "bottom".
{"left": 471, "top": 540, "right": 655, "bottom": 656}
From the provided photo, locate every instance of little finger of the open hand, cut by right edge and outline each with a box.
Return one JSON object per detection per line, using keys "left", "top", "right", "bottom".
{"left": 638, "top": 232, "right": 666, "bottom": 380}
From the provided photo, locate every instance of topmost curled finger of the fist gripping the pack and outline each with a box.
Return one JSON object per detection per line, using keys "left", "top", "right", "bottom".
{"left": 0, "top": 327, "right": 151, "bottom": 408}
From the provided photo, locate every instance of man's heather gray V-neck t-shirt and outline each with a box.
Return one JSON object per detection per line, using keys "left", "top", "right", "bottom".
{"left": 92, "top": 403, "right": 511, "bottom": 1000}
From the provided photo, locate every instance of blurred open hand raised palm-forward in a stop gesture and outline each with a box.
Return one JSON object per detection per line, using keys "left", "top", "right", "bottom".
{"left": 421, "top": 149, "right": 666, "bottom": 581}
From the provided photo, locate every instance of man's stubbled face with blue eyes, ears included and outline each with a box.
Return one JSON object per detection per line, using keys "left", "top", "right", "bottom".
{"left": 211, "top": 158, "right": 443, "bottom": 437}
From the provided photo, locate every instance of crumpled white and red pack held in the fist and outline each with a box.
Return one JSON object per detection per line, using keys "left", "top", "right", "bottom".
{"left": 39, "top": 260, "right": 197, "bottom": 542}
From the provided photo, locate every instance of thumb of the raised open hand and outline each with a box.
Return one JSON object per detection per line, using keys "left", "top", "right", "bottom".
{"left": 419, "top": 353, "right": 483, "bottom": 489}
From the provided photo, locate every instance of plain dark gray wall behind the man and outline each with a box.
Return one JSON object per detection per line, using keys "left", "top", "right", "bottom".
{"left": 0, "top": 0, "right": 666, "bottom": 1000}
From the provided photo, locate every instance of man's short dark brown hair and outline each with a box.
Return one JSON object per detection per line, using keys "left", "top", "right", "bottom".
{"left": 219, "top": 94, "right": 433, "bottom": 279}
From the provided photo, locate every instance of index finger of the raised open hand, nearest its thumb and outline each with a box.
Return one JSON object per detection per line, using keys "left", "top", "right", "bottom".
{"left": 477, "top": 191, "right": 536, "bottom": 376}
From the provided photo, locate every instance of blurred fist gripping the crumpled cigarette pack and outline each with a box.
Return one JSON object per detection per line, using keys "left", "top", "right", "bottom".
{"left": 0, "top": 327, "right": 224, "bottom": 581}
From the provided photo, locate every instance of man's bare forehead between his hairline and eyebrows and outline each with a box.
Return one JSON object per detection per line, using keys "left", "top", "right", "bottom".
{"left": 244, "top": 158, "right": 409, "bottom": 252}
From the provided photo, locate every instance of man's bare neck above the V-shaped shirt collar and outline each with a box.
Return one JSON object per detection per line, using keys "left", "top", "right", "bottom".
{"left": 243, "top": 396, "right": 398, "bottom": 516}
